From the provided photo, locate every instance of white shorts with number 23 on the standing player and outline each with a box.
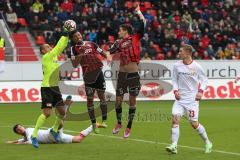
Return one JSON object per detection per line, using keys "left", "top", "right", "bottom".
{"left": 172, "top": 101, "right": 199, "bottom": 121}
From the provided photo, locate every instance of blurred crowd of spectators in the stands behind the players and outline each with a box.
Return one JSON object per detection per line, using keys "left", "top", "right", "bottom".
{"left": 0, "top": 0, "right": 240, "bottom": 60}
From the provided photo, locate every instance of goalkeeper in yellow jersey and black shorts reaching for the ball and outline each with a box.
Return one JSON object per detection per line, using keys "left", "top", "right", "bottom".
{"left": 31, "top": 23, "right": 70, "bottom": 148}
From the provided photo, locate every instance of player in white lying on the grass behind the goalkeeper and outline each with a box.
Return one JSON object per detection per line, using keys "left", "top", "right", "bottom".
{"left": 6, "top": 124, "right": 92, "bottom": 144}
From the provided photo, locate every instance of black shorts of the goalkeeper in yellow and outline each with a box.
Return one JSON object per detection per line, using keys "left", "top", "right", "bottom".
{"left": 41, "top": 86, "right": 64, "bottom": 109}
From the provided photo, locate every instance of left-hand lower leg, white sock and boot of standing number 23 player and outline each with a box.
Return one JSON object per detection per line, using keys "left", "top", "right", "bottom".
{"left": 166, "top": 115, "right": 180, "bottom": 154}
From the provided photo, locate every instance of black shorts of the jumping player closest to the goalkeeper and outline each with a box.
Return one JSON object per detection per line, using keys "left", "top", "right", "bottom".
{"left": 84, "top": 69, "right": 106, "bottom": 96}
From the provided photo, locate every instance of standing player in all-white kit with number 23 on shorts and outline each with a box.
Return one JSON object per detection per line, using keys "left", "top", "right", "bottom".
{"left": 166, "top": 45, "right": 212, "bottom": 154}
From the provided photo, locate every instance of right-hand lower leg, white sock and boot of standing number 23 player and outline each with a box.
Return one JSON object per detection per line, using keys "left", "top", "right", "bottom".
{"left": 191, "top": 122, "right": 213, "bottom": 153}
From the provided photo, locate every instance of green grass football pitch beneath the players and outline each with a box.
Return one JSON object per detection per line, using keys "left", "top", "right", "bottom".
{"left": 0, "top": 100, "right": 240, "bottom": 160}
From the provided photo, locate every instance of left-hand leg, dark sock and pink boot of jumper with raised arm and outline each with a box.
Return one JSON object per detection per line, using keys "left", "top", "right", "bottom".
{"left": 112, "top": 96, "right": 123, "bottom": 134}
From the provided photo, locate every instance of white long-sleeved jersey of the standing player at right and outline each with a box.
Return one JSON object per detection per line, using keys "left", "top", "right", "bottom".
{"left": 172, "top": 60, "right": 207, "bottom": 103}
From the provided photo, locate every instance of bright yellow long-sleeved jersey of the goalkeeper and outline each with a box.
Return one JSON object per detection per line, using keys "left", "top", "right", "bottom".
{"left": 41, "top": 36, "right": 68, "bottom": 87}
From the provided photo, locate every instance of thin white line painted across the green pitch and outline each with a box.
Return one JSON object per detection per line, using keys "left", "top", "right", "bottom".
{"left": 0, "top": 125, "right": 240, "bottom": 156}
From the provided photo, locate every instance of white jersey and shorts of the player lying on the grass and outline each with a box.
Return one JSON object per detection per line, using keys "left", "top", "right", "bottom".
{"left": 18, "top": 128, "right": 73, "bottom": 144}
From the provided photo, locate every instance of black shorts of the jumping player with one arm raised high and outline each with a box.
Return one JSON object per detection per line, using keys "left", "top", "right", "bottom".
{"left": 116, "top": 72, "right": 141, "bottom": 96}
